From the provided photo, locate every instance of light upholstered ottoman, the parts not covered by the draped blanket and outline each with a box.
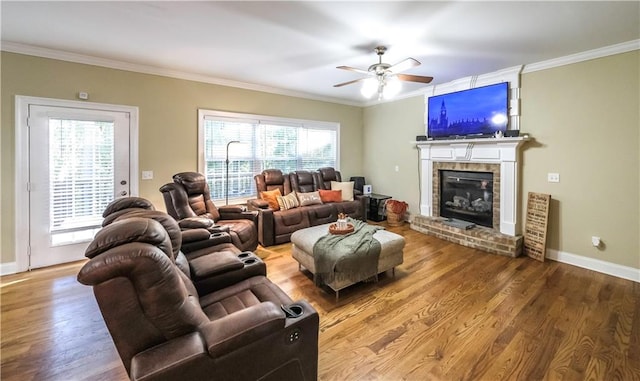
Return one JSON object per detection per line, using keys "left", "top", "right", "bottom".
{"left": 291, "top": 224, "right": 405, "bottom": 299}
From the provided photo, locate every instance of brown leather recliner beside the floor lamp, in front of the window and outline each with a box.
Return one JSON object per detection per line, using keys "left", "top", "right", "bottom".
{"left": 160, "top": 172, "right": 258, "bottom": 251}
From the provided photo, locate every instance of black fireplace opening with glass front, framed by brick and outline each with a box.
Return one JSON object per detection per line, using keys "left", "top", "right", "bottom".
{"left": 439, "top": 170, "right": 493, "bottom": 228}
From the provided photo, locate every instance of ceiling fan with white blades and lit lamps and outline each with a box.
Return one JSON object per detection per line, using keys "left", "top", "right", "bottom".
{"left": 333, "top": 46, "right": 433, "bottom": 100}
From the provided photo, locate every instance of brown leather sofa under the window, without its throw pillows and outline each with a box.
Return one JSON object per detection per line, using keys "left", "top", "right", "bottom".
{"left": 248, "top": 169, "right": 366, "bottom": 246}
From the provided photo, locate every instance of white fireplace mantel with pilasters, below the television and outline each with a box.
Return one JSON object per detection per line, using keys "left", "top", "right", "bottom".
{"left": 413, "top": 136, "right": 529, "bottom": 236}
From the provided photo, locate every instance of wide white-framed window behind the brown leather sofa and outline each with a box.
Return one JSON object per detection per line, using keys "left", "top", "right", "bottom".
{"left": 198, "top": 110, "right": 340, "bottom": 204}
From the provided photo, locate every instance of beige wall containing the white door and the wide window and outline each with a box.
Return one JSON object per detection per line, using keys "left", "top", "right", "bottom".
{"left": 0, "top": 52, "right": 363, "bottom": 263}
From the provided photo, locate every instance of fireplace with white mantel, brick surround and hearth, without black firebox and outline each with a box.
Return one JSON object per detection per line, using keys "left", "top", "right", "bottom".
{"left": 411, "top": 137, "right": 528, "bottom": 257}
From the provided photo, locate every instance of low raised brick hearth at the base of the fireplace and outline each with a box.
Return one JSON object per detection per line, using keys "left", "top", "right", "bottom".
{"left": 411, "top": 216, "right": 522, "bottom": 257}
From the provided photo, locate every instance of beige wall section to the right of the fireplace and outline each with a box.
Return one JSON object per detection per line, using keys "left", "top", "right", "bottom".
{"left": 520, "top": 50, "right": 640, "bottom": 268}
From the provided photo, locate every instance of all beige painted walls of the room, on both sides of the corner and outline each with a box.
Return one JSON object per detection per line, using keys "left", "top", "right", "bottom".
{"left": 0, "top": 51, "right": 640, "bottom": 268}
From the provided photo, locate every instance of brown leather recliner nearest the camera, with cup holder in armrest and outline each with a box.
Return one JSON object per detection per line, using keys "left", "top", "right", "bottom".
{"left": 78, "top": 217, "right": 319, "bottom": 380}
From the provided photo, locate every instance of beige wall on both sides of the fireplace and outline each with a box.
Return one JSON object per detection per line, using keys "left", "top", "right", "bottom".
{"left": 363, "top": 51, "right": 640, "bottom": 268}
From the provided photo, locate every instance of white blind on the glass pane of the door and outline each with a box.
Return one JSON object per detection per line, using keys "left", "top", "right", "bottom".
{"left": 49, "top": 119, "right": 115, "bottom": 233}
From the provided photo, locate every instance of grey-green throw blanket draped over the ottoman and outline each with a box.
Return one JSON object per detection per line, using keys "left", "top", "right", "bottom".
{"left": 313, "top": 218, "right": 383, "bottom": 283}
